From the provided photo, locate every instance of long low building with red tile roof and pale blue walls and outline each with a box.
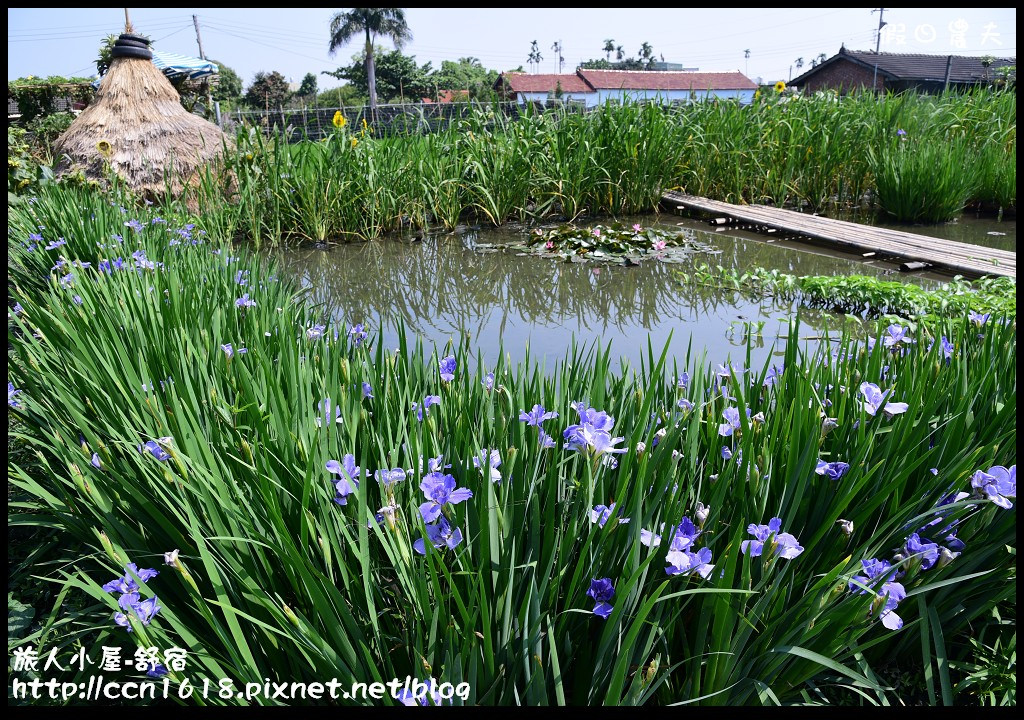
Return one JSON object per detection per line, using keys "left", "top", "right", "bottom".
{"left": 495, "top": 69, "right": 758, "bottom": 108}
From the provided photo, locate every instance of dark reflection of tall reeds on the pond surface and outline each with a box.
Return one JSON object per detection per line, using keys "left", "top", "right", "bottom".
{"left": 268, "top": 219, "right": 868, "bottom": 341}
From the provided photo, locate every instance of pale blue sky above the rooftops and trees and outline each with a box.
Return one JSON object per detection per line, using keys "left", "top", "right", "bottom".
{"left": 7, "top": 7, "right": 1017, "bottom": 89}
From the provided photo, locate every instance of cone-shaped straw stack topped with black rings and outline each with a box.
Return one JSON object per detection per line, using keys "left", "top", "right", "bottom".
{"left": 54, "top": 26, "right": 230, "bottom": 197}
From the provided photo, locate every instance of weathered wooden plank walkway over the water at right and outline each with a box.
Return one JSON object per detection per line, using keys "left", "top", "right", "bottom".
{"left": 662, "top": 193, "right": 1017, "bottom": 279}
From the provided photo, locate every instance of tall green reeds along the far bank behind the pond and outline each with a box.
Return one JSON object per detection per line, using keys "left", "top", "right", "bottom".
{"left": 178, "top": 91, "right": 1017, "bottom": 245}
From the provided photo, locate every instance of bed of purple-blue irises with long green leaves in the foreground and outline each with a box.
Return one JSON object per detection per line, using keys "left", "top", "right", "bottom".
{"left": 8, "top": 183, "right": 1016, "bottom": 705}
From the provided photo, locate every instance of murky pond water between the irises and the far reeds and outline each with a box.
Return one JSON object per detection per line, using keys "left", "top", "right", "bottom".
{"left": 275, "top": 215, "right": 950, "bottom": 369}
